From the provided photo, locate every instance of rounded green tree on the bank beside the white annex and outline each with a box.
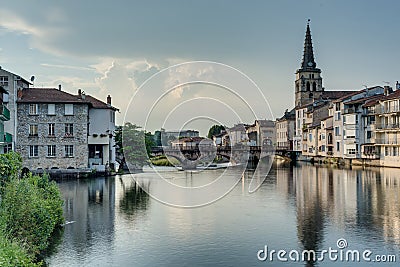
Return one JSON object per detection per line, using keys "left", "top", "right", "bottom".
{"left": 115, "top": 122, "right": 155, "bottom": 166}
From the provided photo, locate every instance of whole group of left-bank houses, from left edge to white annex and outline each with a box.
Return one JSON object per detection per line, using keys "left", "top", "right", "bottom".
{"left": 0, "top": 68, "right": 118, "bottom": 171}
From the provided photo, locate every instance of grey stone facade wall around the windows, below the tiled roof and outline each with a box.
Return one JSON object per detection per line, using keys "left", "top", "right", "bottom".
{"left": 16, "top": 103, "right": 89, "bottom": 170}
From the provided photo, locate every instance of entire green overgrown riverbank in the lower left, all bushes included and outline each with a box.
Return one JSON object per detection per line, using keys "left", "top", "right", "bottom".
{"left": 0, "top": 152, "right": 64, "bottom": 267}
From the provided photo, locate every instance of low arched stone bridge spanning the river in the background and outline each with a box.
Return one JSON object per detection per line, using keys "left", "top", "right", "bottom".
{"left": 156, "top": 145, "right": 274, "bottom": 170}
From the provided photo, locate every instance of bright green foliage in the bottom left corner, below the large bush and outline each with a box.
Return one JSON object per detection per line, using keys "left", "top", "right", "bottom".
{"left": 0, "top": 232, "right": 42, "bottom": 267}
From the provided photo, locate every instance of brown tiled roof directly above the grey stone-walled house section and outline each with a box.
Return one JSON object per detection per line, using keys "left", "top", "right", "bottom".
{"left": 17, "top": 88, "right": 90, "bottom": 104}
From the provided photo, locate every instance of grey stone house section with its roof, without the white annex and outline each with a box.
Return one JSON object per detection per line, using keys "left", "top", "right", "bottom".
{"left": 16, "top": 88, "right": 90, "bottom": 170}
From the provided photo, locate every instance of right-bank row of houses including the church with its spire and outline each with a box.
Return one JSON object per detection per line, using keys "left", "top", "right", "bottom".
{"left": 275, "top": 24, "right": 400, "bottom": 167}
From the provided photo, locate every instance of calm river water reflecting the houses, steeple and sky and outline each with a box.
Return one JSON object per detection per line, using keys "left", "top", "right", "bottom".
{"left": 46, "top": 164, "right": 400, "bottom": 266}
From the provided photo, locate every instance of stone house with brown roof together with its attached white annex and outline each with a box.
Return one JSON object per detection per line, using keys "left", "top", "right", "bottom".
{"left": 16, "top": 86, "right": 119, "bottom": 173}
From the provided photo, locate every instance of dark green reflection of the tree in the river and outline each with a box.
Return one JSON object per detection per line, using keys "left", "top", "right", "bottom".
{"left": 119, "top": 179, "right": 149, "bottom": 219}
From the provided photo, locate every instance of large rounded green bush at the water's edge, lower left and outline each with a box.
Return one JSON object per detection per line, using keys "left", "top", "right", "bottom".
{"left": 0, "top": 174, "right": 64, "bottom": 255}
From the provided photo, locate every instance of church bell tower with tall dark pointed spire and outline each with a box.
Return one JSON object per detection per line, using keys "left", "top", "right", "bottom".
{"left": 295, "top": 20, "right": 324, "bottom": 107}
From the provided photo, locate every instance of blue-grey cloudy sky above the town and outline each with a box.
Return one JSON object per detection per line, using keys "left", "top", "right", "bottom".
{"left": 0, "top": 0, "right": 400, "bottom": 134}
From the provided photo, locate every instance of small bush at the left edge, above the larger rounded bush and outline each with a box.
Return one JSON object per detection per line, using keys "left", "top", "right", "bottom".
{"left": 0, "top": 152, "right": 22, "bottom": 192}
